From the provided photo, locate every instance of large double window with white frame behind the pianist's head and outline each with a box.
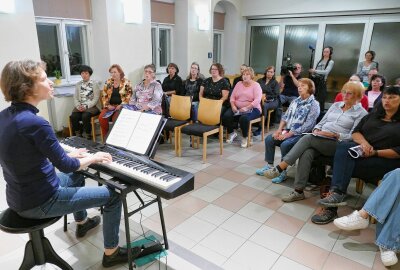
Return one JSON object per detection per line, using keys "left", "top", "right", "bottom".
{"left": 36, "top": 19, "right": 89, "bottom": 82}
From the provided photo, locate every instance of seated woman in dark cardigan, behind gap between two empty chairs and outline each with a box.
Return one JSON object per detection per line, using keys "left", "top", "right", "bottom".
{"left": 182, "top": 62, "right": 203, "bottom": 122}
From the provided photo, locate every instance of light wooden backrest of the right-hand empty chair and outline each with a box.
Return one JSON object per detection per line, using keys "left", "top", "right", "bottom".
{"left": 198, "top": 98, "right": 223, "bottom": 126}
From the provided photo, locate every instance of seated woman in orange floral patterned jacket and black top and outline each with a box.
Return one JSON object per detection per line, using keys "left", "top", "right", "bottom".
{"left": 99, "top": 64, "right": 132, "bottom": 139}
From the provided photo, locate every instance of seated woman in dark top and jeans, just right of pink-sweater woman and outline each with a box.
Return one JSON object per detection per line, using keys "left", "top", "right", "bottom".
{"left": 253, "top": 66, "right": 280, "bottom": 136}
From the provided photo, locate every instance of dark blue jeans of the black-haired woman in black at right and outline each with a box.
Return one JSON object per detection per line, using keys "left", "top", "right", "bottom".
{"left": 331, "top": 142, "right": 400, "bottom": 193}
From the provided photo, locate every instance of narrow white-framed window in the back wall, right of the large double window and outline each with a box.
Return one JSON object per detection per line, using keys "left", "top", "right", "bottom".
{"left": 151, "top": 25, "right": 172, "bottom": 72}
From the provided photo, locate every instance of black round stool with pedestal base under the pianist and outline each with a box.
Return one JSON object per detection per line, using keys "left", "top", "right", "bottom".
{"left": 0, "top": 208, "right": 72, "bottom": 270}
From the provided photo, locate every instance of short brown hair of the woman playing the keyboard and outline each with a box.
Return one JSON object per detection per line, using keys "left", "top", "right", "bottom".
{"left": 0, "top": 60, "right": 44, "bottom": 102}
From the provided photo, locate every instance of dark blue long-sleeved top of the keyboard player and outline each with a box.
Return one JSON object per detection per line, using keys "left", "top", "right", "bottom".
{"left": 0, "top": 103, "right": 79, "bottom": 211}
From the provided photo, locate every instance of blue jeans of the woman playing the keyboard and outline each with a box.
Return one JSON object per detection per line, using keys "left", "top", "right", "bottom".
{"left": 18, "top": 173, "right": 122, "bottom": 248}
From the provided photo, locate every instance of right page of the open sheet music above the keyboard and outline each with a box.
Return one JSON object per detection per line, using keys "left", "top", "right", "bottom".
{"left": 126, "top": 113, "right": 161, "bottom": 154}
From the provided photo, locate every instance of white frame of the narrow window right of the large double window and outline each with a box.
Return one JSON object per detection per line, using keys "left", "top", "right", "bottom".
{"left": 151, "top": 23, "right": 174, "bottom": 74}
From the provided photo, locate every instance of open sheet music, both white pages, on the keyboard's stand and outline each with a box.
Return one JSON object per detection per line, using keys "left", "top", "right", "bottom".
{"left": 106, "top": 109, "right": 162, "bottom": 155}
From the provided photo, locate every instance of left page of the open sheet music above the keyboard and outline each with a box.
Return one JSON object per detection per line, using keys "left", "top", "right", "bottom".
{"left": 106, "top": 109, "right": 141, "bottom": 148}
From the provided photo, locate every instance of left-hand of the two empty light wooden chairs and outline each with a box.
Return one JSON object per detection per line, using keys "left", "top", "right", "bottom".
{"left": 164, "top": 95, "right": 192, "bottom": 155}
